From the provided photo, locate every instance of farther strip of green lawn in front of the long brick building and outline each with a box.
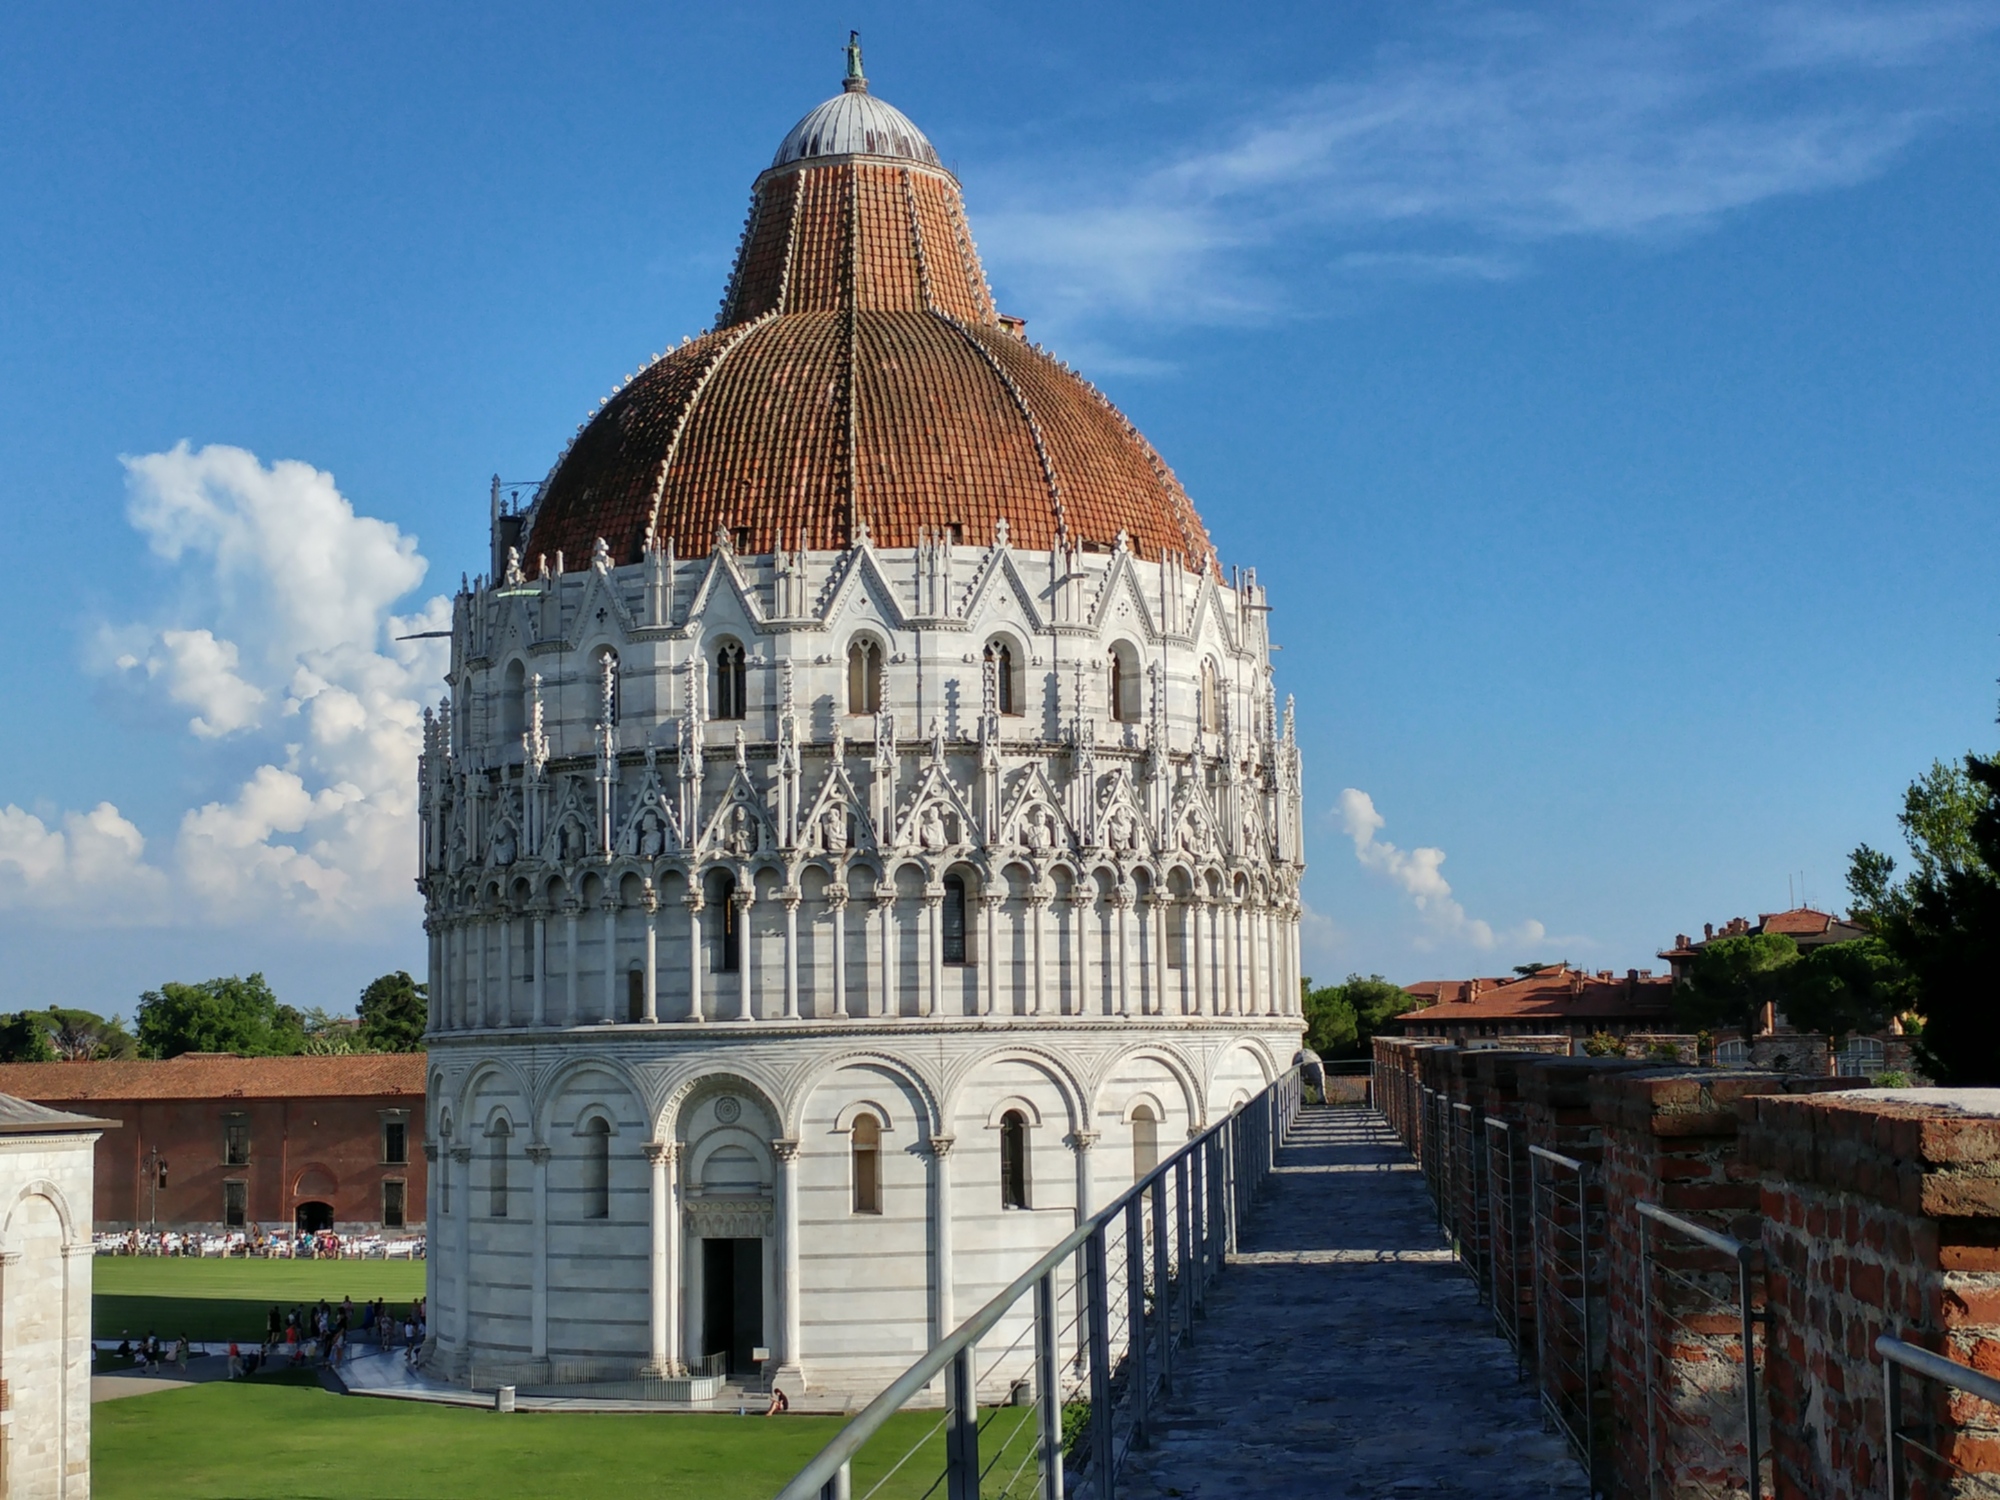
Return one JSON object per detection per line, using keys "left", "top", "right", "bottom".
{"left": 90, "top": 1256, "right": 424, "bottom": 1340}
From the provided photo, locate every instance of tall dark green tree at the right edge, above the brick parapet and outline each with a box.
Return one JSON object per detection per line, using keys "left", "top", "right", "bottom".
{"left": 1848, "top": 754, "right": 2000, "bottom": 1088}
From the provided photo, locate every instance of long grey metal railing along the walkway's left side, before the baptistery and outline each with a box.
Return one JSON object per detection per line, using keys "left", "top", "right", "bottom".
{"left": 778, "top": 1070, "right": 1300, "bottom": 1500}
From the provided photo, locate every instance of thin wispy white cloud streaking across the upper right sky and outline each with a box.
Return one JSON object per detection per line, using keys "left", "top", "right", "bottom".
{"left": 980, "top": 0, "right": 2000, "bottom": 324}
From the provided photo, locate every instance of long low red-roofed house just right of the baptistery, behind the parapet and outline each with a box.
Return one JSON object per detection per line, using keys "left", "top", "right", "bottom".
{"left": 1396, "top": 964, "right": 1674, "bottom": 1042}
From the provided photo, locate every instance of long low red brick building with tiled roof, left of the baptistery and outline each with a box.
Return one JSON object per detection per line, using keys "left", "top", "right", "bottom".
{"left": 0, "top": 1052, "right": 424, "bottom": 1234}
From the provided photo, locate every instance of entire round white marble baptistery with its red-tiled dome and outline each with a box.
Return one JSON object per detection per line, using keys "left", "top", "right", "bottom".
{"left": 420, "top": 48, "right": 1302, "bottom": 1392}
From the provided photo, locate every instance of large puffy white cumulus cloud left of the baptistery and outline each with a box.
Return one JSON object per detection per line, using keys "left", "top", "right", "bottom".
{"left": 0, "top": 444, "right": 450, "bottom": 926}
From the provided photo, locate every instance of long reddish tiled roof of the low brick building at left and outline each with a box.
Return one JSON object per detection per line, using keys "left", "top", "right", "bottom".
{"left": 0, "top": 1052, "right": 424, "bottom": 1104}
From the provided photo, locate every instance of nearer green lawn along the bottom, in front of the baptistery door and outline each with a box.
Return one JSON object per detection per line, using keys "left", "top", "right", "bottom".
{"left": 92, "top": 1380, "right": 1034, "bottom": 1500}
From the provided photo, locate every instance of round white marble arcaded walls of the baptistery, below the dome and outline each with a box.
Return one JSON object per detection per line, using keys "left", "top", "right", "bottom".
{"left": 422, "top": 532, "right": 1302, "bottom": 1390}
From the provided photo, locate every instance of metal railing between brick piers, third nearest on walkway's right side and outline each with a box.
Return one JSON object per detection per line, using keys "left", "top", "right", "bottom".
{"left": 1528, "top": 1146, "right": 1610, "bottom": 1488}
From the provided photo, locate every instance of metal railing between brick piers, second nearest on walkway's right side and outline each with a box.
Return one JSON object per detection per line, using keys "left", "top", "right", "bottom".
{"left": 1638, "top": 1204, "right": 1770, "bottom": 1500}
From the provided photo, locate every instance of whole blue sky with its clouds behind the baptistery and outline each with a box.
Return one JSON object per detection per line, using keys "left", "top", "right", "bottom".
{"left": 0, "top": 2, "right": 2000, "bottom": 1010}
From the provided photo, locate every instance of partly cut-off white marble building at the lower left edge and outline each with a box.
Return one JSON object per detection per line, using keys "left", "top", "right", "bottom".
{"left": 0, "top": 1094, "right": 108, "bottom": 1500}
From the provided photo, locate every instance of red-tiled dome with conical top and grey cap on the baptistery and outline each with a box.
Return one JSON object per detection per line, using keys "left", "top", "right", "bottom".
{"left": 522, "top": 48, "right": 1212, "bottom": 574}
